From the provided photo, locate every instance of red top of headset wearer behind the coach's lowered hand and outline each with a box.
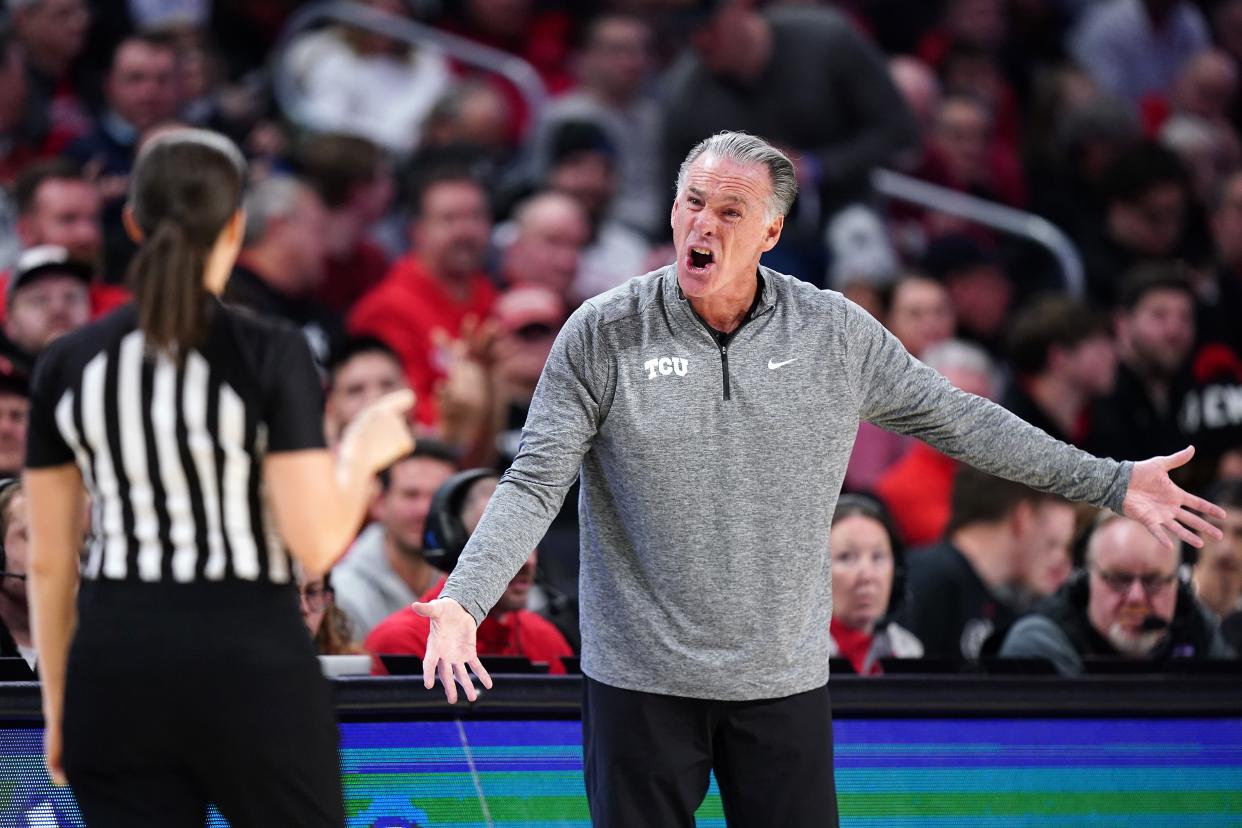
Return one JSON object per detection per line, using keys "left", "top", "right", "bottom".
{"left": 363, "top": 578, "right": 574, "bottom": 675}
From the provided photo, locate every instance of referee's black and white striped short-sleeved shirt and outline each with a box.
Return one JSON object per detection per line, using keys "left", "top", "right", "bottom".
{"left": 26, "top": 304, "right": 324, "bottom": 583}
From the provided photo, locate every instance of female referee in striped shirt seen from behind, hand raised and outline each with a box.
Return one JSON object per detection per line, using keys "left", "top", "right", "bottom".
{"left": 25, "top": 129, "right": 412, "bottom": 828}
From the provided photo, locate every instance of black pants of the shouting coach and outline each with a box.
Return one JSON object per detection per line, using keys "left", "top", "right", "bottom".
{"left": 582, "top": 678, "right": 837, "bottom": 828}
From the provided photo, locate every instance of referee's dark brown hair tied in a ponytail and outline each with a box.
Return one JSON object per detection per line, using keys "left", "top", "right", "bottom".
{"left": 128, "top": 129, "right": 246, "bottom": 361}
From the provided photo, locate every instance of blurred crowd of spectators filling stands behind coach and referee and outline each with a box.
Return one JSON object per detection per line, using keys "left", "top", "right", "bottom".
{"left": 0, "top": 0, "right": 1242, "bottom": 674}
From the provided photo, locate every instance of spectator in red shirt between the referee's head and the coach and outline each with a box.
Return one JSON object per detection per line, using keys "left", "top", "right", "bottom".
{"left": 349, "top": 169, "right": 497, "bottom": 426}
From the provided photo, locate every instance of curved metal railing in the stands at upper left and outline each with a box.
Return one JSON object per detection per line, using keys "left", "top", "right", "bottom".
{"left": 270, "top": 0, "right": 548, "bottom": 140}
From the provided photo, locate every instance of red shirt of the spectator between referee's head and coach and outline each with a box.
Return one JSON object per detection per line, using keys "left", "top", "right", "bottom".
{"left": 349, "top": 253, "right": 497, "bottom": 426}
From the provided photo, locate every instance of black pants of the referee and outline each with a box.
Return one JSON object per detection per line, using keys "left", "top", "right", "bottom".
{"left": 65, "top": 583, "right": 345, "bottom": 828}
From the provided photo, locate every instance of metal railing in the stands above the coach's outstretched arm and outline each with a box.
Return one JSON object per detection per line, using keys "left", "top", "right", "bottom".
{"left": 871, "top": 169, "right": 1086, "bottom": 298}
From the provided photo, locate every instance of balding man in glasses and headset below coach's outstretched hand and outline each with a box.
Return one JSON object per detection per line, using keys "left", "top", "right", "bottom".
{"left": 1001, "top": 514, "right": 1232, "bottom": 675}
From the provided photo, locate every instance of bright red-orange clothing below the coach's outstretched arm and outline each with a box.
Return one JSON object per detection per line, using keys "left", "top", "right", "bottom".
{"left": 876, "top": 442, "right": 958, "bottom": 546}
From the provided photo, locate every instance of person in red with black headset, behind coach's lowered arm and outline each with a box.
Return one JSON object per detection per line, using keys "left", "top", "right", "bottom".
{"left": 364, "top": 475, "right": 574, "bottom": 675}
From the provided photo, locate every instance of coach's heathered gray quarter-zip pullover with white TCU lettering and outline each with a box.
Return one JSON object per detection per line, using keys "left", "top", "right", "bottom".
{"left": 441, "top": 266, "right": 1131, "bottom": 700}
